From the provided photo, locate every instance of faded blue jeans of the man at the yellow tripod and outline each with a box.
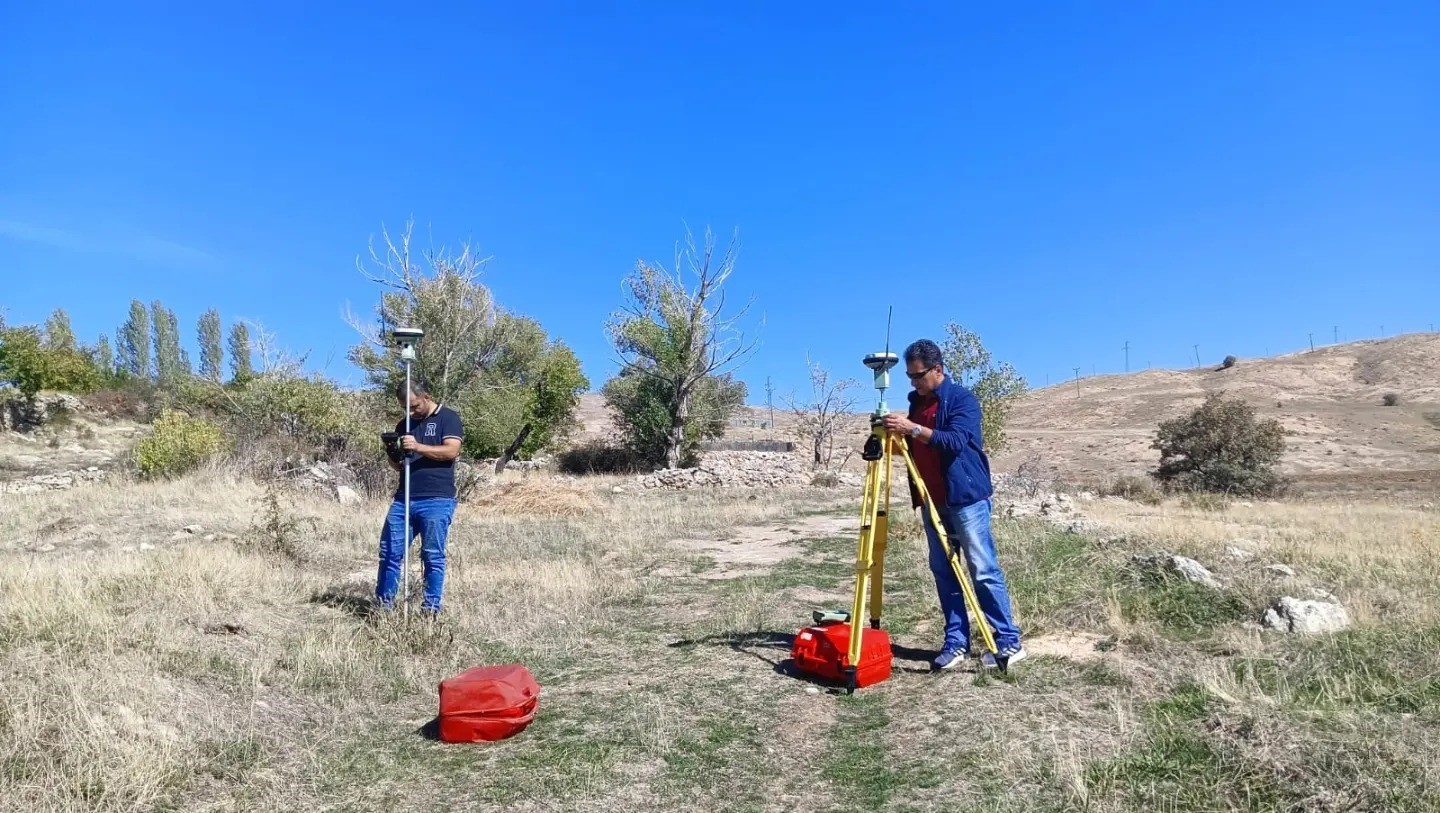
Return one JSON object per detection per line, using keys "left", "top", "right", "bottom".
{"left": 920, "top": 499, "right": 1020, "bottom": 650}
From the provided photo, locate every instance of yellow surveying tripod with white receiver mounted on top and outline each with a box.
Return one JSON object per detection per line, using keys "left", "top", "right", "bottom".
{"left": 845, "top": 350, "right": 1007, "bottom": 692}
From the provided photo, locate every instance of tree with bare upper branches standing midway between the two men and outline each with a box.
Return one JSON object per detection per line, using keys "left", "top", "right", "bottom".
{"left": 606, "top": 227, "right": 756, "bottom": 468}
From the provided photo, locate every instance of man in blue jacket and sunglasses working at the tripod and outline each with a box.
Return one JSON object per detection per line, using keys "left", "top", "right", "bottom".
{"left": 884, "top": 338, "right": 1025, "bottom": 669}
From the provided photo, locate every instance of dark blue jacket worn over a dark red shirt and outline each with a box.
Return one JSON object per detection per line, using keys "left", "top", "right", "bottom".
{"left": 909, "top": 376, "right": 995, "bottom": 508}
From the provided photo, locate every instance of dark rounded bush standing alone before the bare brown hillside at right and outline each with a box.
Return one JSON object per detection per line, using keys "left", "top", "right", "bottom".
{"left": 1151, "top": 393, "right": 1284, "bottom": 496}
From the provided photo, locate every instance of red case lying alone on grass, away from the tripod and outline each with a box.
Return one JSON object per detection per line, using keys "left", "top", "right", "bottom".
{"left": 439, "top": 663, "right": 540, "bottom": 742}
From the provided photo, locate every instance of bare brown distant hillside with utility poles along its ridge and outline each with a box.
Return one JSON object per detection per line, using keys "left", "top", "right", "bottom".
{"left": 580, "top": 334, "right": 1440, "bottom": 481}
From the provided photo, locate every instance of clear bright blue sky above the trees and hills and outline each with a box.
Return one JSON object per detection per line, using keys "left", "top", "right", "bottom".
{"left": 0, "top": 0, "right": 1440, "bottom": 403}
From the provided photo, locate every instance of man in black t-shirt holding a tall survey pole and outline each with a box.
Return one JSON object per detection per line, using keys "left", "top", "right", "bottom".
{"left": 374, "top": 381, "right": 464, "bottom": 613}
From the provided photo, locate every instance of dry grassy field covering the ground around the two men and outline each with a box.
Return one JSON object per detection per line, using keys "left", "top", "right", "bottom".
{"left": 0, "top": 472, "right": 1440, "bottom": 813}
